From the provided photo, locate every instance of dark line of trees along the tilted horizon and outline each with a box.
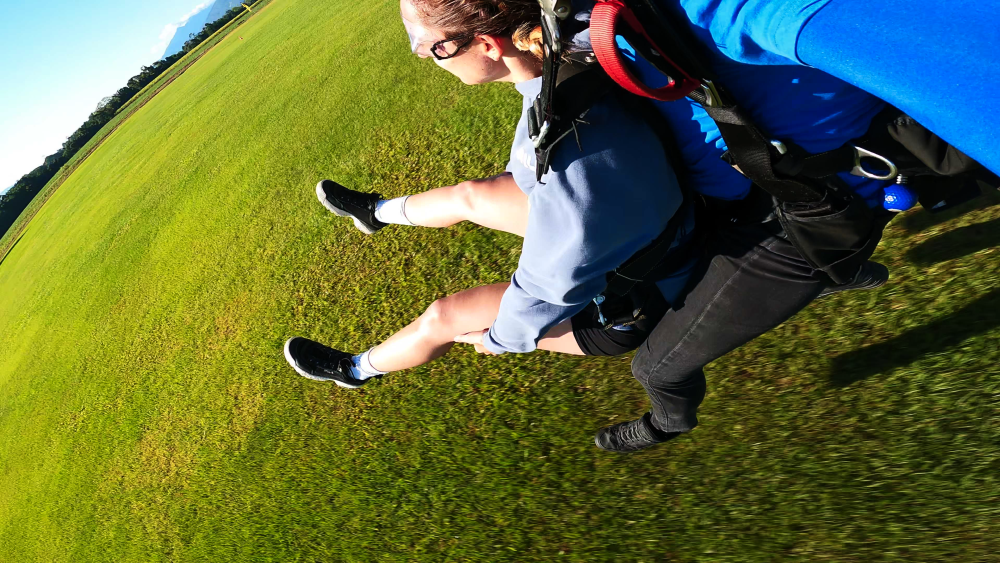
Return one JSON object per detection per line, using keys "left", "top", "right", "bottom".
{"left": 0, "top": 7, "right": 243, "bottom": 240}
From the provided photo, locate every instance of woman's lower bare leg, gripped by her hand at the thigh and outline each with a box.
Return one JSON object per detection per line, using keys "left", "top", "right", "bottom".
{"left": 368, "top": 282, "right": 583, "bottom": 372}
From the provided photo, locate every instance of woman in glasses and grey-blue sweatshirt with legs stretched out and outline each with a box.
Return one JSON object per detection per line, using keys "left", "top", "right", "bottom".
{"left": 284, "top": 0, "right": 704, "bottom": 454}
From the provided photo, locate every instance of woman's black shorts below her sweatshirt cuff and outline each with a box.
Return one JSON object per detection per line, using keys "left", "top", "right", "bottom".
{"left": 570, "top": 288, "right": 670, "bottom": 356}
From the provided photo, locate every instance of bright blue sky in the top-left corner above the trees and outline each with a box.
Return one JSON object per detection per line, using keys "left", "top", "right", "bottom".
{"left": 0, "top": 0, "right": 217, "bottom": 191}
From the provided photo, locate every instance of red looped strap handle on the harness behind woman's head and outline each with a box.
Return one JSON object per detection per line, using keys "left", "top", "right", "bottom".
{"left": 590, "top": 0, "right": 701, "bottom": 102}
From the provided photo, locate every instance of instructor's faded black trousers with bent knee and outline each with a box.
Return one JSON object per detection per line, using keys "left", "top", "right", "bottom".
{"left": 632, "top": 220, "right": 831, "bottom": 432}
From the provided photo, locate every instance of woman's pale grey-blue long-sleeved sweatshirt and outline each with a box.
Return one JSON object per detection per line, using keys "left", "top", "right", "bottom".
{"left": 483, "top": 78, "right": 694, "bottom": 354}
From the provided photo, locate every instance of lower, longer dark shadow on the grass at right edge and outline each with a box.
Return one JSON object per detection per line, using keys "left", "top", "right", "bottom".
{"left": 830, "top": 288, "right": 1000, "bottom": 387}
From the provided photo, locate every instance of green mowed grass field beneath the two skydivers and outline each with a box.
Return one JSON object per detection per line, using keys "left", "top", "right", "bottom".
{"left": 0, "top": 0, "right": 1000, "bottom": 562}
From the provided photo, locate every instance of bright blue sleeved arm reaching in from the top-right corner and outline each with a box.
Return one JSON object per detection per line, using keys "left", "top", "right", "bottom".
{"left": 794, "top": 0, "right": 1000, "bottom": 173}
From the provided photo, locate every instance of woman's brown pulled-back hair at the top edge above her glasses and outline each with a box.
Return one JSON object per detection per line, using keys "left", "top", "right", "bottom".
{"left": 410, "top": 0, "right": 543, "bottom": 59}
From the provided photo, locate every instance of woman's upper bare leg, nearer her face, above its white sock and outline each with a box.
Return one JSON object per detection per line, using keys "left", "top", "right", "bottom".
{"left": 405, "top": 173, "right": 528, "bottom": 237}
